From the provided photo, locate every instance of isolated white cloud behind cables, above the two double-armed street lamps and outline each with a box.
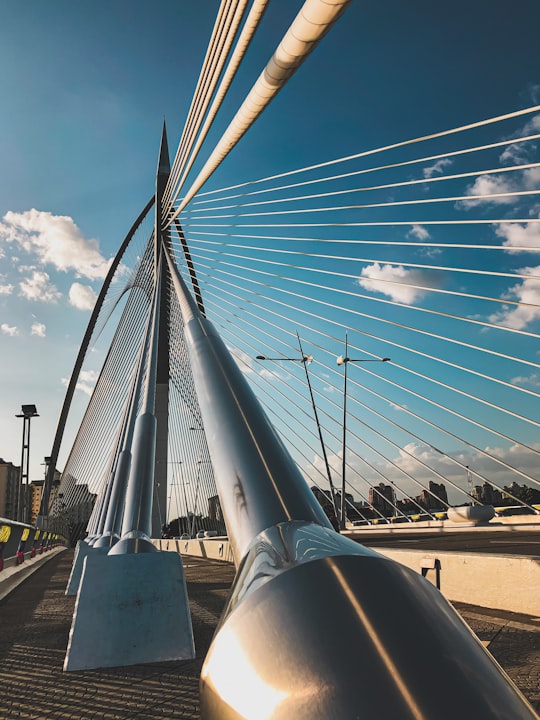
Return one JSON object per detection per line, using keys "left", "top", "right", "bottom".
{"left": 358, "top": 263, "right": 440, "bottom": 305}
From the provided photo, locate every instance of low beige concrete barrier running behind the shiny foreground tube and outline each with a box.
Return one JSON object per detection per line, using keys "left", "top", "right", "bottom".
{"left": 161, "top": 538, "right": 540, "bottom": 616}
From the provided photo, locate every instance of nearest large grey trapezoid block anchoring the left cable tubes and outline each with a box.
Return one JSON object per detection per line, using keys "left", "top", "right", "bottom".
{"left": 64, "top": 552, "right": 195, "bottom": 671}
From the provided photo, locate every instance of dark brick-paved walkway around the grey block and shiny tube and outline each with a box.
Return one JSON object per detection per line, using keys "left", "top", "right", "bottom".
{"left": 0, "top": 552, "right": 540, "bottom": 720}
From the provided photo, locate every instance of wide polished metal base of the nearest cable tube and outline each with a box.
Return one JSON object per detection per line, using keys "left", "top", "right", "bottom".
{"left": 201, "top": 522, "right": 536, "bottom": 720}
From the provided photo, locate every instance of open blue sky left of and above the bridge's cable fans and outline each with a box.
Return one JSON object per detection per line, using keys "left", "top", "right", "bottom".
{"left": 0, "top": 0, "right": 540, "bottom": 490}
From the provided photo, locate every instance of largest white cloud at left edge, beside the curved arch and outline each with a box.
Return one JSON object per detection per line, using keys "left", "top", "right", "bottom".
{"left": 0, "top": 210, "right": 109, "bottom": 280}
